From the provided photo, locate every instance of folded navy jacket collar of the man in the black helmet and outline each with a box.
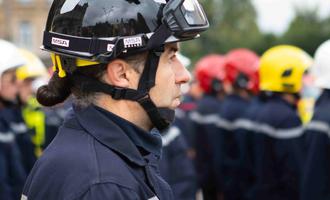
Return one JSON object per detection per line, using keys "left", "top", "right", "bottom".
{"left": 73, "top": 105, "right": 150, "bottom": 166}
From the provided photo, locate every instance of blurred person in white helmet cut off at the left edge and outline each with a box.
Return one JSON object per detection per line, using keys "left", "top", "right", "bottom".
{"left": 0, "top": 40, "right": 26, "bottom": 200}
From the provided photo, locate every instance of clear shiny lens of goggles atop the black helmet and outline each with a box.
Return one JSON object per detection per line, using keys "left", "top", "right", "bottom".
{"left": 181, "top": 0, "right": 207, "bottom": 26}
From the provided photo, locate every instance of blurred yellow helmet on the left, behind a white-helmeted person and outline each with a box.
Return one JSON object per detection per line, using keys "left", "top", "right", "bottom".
{"left": 16, "top": 49, "right": 48, "bottom": 80}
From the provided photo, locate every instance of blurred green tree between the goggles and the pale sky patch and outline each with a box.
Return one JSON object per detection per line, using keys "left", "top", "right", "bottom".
{"left": 182, "top": 0, "right": 262, "bottom": 62}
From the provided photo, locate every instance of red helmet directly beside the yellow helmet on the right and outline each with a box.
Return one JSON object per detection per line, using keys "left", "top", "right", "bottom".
{"left": 224, "top": 49, "right": 259, "bottom": 93}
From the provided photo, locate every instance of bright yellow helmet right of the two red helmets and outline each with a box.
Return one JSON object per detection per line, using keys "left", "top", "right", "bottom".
{"left": 259, "top": 45, "right": 312, "bottom": 93}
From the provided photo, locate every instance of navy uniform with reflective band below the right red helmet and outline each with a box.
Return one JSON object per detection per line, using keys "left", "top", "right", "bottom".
{"left": 213, "top": 94, "right": 249, "bottom": 199}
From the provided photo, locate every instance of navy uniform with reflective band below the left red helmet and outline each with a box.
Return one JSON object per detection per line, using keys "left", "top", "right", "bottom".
{"left": 190, "top": 95, "right": 221, "bottom": 200}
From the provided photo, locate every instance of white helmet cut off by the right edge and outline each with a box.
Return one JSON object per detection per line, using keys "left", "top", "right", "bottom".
{"left": 311, "top": 40, "right": 330, "bottom": 89}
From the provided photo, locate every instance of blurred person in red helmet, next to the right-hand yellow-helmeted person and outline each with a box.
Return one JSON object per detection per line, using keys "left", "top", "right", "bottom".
{"left": 212, "top": 49, "right": 259, "bottom": 200}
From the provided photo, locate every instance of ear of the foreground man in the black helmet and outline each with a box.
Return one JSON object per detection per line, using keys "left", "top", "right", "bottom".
{"left": 104, "top": 59, "right": 138, "bottom": 88}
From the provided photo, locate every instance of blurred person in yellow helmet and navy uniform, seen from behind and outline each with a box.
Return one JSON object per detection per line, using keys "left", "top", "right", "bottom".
{"left": 249, "top": 45, "right": 312, "bottom": 200}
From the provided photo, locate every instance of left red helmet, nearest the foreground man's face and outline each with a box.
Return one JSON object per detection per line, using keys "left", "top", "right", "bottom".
{"left": 195, "top": 54, "right": 225, "bottom": 93}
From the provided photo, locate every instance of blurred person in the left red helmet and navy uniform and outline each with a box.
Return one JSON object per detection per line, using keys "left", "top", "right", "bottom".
{"left": 190, "top": 54, "right": 225, "bottom": 200}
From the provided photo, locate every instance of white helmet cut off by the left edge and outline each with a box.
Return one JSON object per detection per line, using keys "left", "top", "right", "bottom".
{"left": 0, "top": 39, "right": 24, "bottom": 76}
